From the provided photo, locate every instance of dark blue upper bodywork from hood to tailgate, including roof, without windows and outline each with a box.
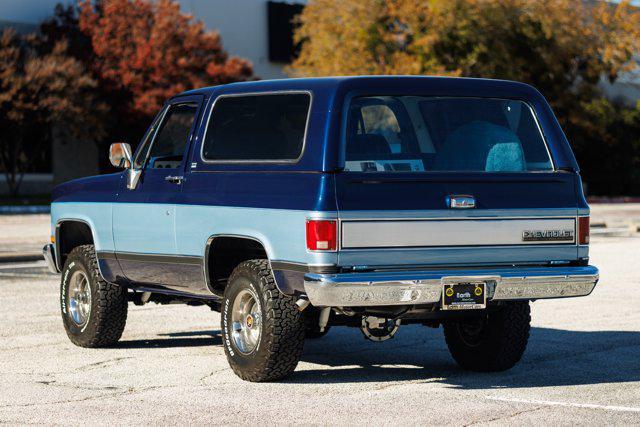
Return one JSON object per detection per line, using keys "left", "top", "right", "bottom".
{"left": 53, "top": 76, "right": 586, "bottom": 211}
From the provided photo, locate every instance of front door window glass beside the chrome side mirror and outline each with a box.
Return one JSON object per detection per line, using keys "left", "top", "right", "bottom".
{"left": 146, "top": 104, "right": 198, "bottom": 169}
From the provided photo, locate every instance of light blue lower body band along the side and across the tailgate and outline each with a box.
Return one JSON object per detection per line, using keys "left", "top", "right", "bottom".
{"left": 51, "top": 202, "right": 588, "bottom": 300}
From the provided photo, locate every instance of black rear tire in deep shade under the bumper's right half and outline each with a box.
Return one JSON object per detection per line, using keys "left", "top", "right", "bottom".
{"left": 444, "top": 301, "right": 531, "bottom": 372}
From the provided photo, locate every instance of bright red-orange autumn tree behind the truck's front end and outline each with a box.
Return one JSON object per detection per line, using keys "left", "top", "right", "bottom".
{"left": 79, "top": 0, "right": 253, "bottom": 117}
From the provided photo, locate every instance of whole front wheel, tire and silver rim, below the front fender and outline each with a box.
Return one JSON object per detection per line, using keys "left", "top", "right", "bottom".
{"left": 60, "top": 245, "right": 127, "bottom": 347}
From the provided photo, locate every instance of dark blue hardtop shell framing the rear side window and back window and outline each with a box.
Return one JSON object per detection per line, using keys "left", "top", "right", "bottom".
{"left": 178, "top": 76, "right": 578, "bottom": 172}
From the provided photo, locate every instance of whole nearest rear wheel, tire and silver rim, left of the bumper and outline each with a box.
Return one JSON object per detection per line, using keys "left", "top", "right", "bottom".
{"left": 221, "top": 259, "right": 306, "bottom": 382}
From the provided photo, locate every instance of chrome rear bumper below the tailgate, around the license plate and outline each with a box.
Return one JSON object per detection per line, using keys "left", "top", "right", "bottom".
{"left": 304, "top": 266, "right": 599, "bottom": 307}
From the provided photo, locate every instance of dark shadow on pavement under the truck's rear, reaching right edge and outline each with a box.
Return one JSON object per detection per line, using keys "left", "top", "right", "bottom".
{"left": 288, "top": 326, "right": 640, "bottom": 389}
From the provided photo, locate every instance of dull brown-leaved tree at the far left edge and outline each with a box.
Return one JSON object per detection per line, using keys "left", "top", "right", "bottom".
{"left": 0, "top": 30, "right": 105, "bottom": 196}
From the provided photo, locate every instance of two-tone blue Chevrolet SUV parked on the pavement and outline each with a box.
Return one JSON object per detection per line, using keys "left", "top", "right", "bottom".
{"left": 44, "top": 77, "right": 598, "bottom": 381}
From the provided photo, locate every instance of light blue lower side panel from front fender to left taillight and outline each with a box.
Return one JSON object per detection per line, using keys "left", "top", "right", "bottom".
{"left": 52, "top": 202, "right": 337, "bottom": 295}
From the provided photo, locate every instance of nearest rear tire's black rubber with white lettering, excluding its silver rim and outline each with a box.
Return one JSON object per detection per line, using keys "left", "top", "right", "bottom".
{"left": 220, "top": 259, "right": 305, "bottom": 382}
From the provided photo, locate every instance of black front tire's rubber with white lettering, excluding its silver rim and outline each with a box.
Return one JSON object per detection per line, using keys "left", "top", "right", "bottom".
{"left": 60, "top": 245, "right": 127, "bottom": 348}
